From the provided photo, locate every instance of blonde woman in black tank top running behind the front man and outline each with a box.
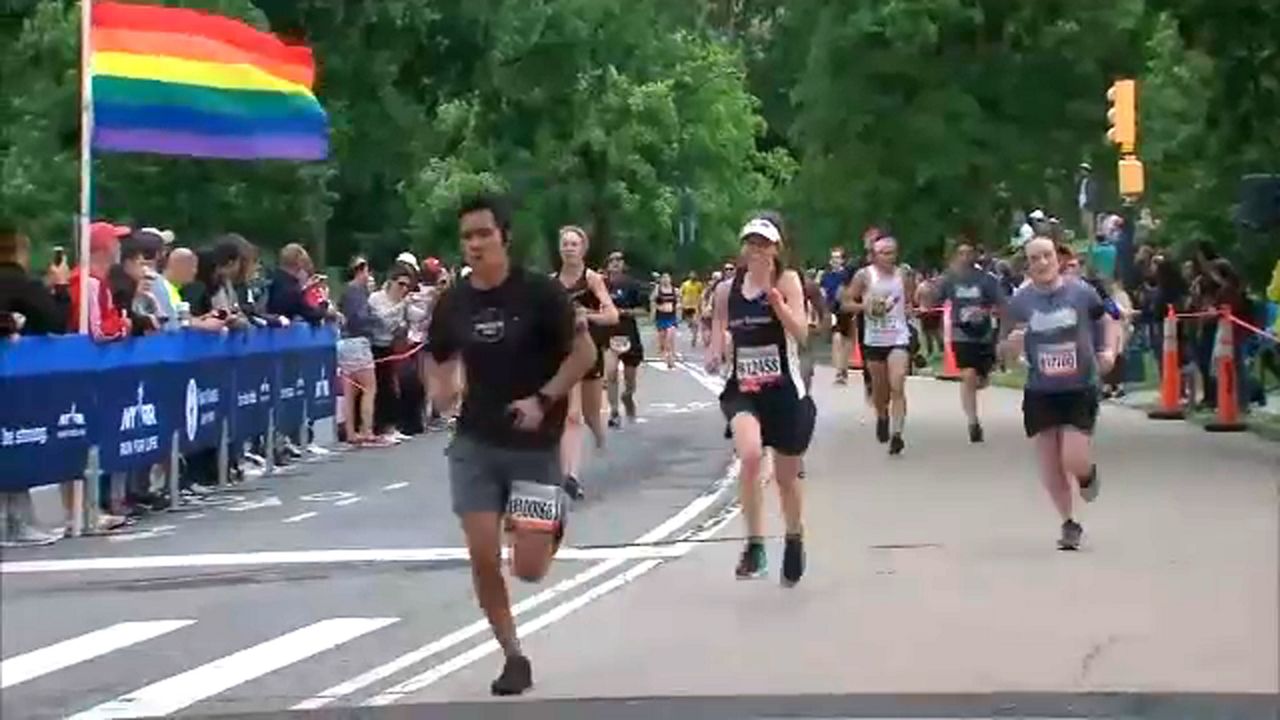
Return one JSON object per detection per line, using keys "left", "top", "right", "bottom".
{"left": 556, "top": 225, "right": 618, "bottom": 500}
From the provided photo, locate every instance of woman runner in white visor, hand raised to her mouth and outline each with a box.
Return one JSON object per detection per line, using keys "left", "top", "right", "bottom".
{"left": 707, "top": 215, "right": 817, "bottom": 587}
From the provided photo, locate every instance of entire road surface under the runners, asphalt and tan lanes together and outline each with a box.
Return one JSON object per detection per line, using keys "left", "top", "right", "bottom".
{"left": 0, "top": 333, "right": 1280, "bottom": 719}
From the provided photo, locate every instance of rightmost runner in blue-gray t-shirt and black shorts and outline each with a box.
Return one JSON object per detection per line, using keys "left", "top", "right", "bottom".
{"left": 1002, "top": 237, "right": 1120, "bottom": 550}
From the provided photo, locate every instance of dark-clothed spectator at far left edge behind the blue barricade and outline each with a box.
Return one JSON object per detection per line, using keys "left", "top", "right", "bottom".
{"left": 0, "top": 227, "right": 65, "bottom": 547}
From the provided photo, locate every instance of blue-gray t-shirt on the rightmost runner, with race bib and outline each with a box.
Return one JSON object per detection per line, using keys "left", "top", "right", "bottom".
{"left": 1009, "top": 278, "right": 1106, "bottom": 392}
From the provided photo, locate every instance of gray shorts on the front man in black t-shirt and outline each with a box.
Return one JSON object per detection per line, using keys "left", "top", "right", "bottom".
{"left": 444, "top": 434, "right": 563, "bottom": 515}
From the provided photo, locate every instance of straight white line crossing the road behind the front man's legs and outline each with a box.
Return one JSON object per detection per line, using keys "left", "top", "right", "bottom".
{"left": 0, "top": 547, "right": 691, "bottom": 575}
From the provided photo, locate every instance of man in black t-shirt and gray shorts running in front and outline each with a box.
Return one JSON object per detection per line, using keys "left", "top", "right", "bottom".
{"left": 428, "top": 196, "right": 595, "bottom": 694}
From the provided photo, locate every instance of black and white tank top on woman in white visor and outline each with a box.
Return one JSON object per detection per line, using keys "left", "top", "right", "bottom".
{"left": 727, "top": 270, "right": 805, "bottom": 398}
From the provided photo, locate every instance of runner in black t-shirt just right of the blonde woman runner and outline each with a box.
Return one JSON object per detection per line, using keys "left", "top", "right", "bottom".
{"left": 602, "top": 252, "right": 649, "bottom": 428}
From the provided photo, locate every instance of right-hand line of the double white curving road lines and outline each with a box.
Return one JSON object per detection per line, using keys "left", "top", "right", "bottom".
{"left": 364, "top": 506, "right": 739, "bottom": 707}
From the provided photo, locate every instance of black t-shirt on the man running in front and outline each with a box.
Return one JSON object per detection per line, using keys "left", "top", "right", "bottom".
{"left": 428, "top": 268, "right": 575, "bottom": 450}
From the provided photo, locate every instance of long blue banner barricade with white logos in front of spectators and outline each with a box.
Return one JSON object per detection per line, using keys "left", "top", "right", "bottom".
{"left": 0, "top": 324, "right": 338, "bottom": 491}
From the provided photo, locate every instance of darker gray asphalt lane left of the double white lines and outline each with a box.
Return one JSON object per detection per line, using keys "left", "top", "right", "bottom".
{"left": 0, "top": 333, "right": 732, "bottom": 720}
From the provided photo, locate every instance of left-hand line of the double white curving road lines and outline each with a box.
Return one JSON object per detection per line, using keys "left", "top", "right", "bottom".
{"left": 291, "top": 459, "right": 739, "bottom": 710}
